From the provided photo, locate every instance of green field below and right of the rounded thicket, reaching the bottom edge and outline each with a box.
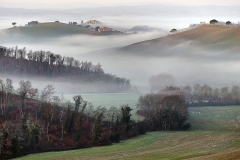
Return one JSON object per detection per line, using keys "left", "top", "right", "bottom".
{"left": 15, "top": 106, "right": 240, "bottom": 160}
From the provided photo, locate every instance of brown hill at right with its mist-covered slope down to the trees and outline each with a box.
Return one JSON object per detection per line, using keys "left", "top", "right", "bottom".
{"left": 79, "top": 25, "right": 240, "bottom": 89}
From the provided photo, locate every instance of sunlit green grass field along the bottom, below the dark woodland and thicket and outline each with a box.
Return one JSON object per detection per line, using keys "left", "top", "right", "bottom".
{"left": 14, "top": 131, "right": 240, "bottom": 160}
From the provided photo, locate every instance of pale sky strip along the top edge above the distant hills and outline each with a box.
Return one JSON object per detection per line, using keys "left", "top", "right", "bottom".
{"left": 0, "top": 0, "right": 240, "bottom": 8}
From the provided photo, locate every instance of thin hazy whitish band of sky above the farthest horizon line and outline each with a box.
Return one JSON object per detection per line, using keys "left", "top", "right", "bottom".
{"left": 0, "top": 0, "right": 240, "bottom": 9}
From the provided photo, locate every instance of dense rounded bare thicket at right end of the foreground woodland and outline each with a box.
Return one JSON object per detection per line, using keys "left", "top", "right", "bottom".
{"left": 137, "top": 93, "right": 190, "bottom": 131}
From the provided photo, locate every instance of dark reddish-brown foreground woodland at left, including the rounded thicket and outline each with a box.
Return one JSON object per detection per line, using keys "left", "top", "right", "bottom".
{"left": 0, "top": 79, "right": 190, "bottom": 159}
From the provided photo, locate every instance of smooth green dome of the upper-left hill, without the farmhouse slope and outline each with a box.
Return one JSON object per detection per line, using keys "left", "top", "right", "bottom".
{"left": 0, "top": 22, "right": 92, "bottom": 38}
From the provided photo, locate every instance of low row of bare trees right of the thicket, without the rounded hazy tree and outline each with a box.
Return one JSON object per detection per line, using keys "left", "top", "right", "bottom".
{"left": 161, "top": 84, "right": 240, "bottom": 107}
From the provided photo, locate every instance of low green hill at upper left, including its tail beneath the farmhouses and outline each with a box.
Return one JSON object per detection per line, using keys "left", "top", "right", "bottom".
{"left": 0, "top": 22, "right": 126, "bottom": 43}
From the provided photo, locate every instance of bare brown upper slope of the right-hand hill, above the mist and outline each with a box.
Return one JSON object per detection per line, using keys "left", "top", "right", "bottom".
{"left": 119, "top": 25, "right": 240, "bottom": 56}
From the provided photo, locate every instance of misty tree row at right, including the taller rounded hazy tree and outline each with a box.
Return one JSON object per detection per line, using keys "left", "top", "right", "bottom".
{"left": 149, "top": 73, "right": 240, "bottom": 106}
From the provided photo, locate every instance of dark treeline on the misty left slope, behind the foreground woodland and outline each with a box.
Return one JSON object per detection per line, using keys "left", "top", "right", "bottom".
{"left": 0, "top": 46, "right": 130, "bottom": 92}
